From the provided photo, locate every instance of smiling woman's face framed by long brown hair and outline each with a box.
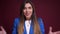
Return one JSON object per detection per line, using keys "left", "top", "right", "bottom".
{"left": 23, "top": 3, "right": 33, "bottom": 19}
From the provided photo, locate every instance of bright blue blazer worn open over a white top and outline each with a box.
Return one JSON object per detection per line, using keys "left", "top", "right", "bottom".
{"left": 12, "top": 18, "right": 45, "bottom": 34}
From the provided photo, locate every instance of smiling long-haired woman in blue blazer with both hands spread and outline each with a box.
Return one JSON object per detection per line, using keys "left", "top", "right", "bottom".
{"left": 0, "top": 0, "right": 59, "bottom": 34}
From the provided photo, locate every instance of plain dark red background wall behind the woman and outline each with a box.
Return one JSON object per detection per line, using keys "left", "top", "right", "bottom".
{"left": 0, "top": 0, "right": 60, "bottom": 34}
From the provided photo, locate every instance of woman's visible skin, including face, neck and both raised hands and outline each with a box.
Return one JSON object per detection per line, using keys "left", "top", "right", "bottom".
{"left": 0, "top": 3, "right": 60, "bottom": 34}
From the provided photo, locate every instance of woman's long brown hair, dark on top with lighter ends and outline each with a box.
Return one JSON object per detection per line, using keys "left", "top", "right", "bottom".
{"left": 18, "top": 0, "right": 41, "bottom": 34}
